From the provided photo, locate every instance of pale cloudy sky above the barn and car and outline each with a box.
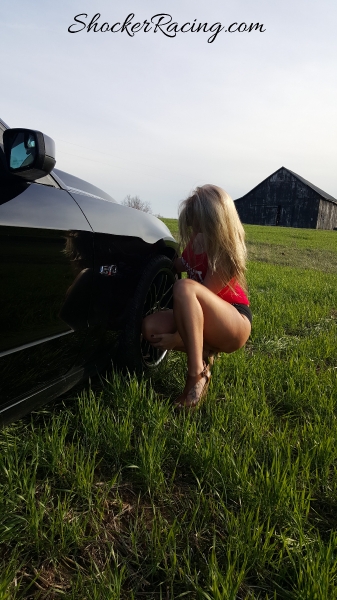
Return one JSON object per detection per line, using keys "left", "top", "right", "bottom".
{"left": 0, "top": 0, "right": 337, "bottom": 218}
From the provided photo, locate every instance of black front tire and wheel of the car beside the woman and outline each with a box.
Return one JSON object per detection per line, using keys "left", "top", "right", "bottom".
{"left": 118, "top": 254, "right": 177, "bottom": 375}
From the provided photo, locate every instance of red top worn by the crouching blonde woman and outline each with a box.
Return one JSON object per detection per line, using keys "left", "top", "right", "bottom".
{"left": 181, "top": 241, "right": 249, "bottom": 306}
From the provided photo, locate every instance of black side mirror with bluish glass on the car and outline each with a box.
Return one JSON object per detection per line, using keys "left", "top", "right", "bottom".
{"left": 3, "top": 129, "right": 56, "bottom": 181}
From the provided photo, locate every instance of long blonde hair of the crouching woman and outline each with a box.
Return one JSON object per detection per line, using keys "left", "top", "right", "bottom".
{"left": 179, "top": 184, "right": 247, "bottom": 291}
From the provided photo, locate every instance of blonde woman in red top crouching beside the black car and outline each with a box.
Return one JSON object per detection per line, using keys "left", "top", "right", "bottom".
{"left": 143, "top": 185, "right": 252, "bottom": 409}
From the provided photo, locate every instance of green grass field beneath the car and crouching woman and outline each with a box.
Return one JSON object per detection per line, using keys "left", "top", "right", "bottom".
{"left": 0, "top": 219, "right": 337, "bottom": 600}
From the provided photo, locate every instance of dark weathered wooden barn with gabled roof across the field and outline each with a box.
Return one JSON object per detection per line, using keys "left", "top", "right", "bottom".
{"left": 235, "top": 167, "right": 337, "bottom": 229}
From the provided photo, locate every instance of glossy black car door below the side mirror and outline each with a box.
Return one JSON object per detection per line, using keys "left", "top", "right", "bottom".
{"left": 0, "top": 124, "right": 93, "bottom": 412}
